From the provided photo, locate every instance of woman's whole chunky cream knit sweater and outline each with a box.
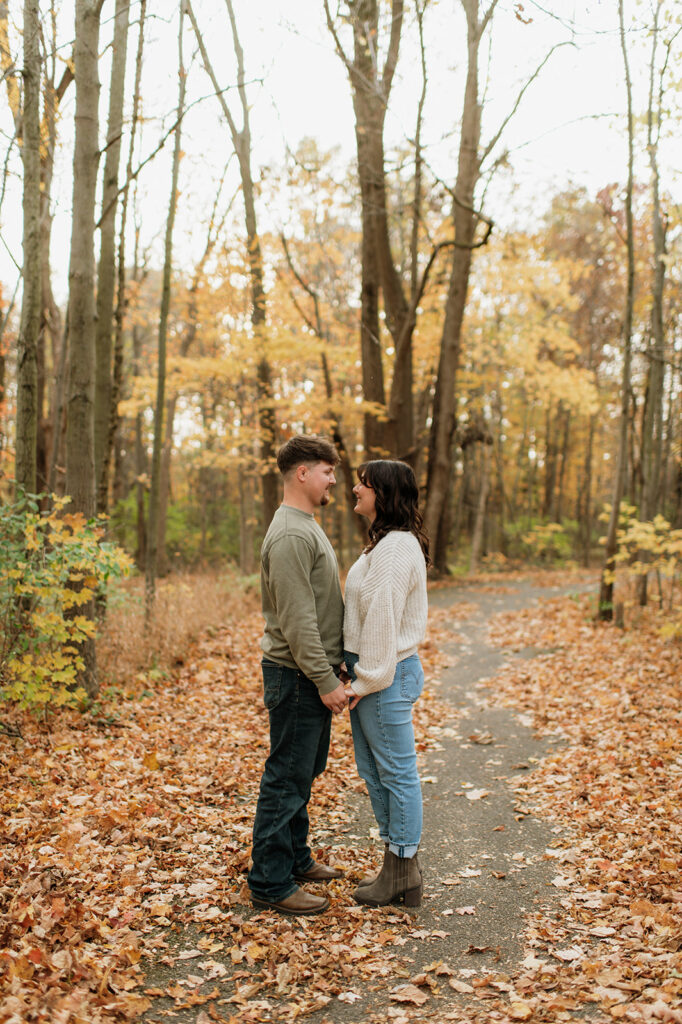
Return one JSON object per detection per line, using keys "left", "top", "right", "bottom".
{"left": 343, "top": 529, "right": 427, "bottom": 696}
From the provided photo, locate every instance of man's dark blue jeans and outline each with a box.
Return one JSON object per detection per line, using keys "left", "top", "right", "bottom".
{"left": 249, "top": 658, "right": 332, "bottom": 903}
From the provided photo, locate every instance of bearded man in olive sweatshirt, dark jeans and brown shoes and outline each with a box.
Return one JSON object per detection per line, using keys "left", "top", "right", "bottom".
{"left": 248, "top": 436, "right": 348, "bottom": 914}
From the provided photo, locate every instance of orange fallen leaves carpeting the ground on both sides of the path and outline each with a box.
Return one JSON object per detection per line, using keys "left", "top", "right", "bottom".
{"left": 0, "top": 577, "right": 682, "bottom": 1024}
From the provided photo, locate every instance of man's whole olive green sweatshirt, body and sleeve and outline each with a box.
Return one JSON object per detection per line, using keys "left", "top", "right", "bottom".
{"left": 260, "top": 505, "right": 343, "bottom": 695}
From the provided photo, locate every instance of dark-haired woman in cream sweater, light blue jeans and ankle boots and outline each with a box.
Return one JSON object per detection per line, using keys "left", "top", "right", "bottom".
{"left": 343, "top": 459, "right": 428, "bottom": 906}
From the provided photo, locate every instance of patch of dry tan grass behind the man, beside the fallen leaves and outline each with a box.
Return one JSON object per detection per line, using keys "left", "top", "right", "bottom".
{"left": 97, "top": 566, "right": 259, "bottom": 689}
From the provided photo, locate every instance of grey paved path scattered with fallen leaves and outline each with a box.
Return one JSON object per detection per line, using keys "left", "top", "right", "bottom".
{"left": 145, "top": 581, "right": 587, "bottom": 1024}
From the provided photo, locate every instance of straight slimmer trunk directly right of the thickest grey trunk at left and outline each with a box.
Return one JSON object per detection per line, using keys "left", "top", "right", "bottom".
{"left": 95, "top": 0, "right": 130, "bottom": 513}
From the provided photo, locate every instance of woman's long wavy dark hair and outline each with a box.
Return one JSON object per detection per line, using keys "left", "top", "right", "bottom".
{"left": 357, "top": 459, "right": 431, "bottom": 565}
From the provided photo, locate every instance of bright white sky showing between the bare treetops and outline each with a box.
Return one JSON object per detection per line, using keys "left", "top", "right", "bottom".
{"left": 0, "top": 0, "right": 682, "bottom": 299}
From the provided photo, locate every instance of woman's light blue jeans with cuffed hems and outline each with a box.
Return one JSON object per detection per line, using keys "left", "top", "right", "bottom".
{"left": 343, "top": 651, "right": 424, "bottom": 857}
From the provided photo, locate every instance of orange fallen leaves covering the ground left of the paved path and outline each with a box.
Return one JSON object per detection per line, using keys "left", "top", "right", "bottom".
{"left": 0, "top": 589, "right": 453, "bottom": 1024}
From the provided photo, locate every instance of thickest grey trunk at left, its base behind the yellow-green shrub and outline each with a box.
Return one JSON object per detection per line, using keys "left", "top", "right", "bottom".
{"left": 67, "top": 0, "right": 102, "bottom": 696}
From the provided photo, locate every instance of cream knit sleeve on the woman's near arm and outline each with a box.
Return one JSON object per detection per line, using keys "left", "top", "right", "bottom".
{"left": 351, "top": 546, "right": 412, "bottom": 696}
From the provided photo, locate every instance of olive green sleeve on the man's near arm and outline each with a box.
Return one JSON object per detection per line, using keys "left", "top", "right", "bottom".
{"left": 268, "top": 535, "right": 339, "bottom": 695}
